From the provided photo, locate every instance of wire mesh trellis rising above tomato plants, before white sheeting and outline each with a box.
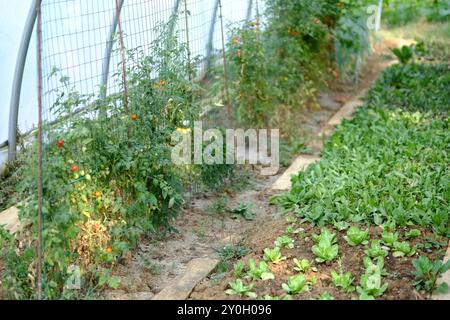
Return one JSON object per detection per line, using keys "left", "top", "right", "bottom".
{"left": 37, "top": 0, "right": 254, "bottom": 125}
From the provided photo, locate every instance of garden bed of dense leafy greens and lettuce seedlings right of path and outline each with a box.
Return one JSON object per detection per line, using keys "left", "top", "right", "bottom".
{"left": 191, "top": 59, "right": 450, "bottom": 299}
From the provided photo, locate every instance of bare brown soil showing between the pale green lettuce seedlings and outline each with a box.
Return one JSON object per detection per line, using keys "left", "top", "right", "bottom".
{"left": 190, "top": 223, "right": 447, "bottom": 300}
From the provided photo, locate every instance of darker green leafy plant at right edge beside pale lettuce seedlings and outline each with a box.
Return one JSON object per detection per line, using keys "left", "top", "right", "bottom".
{"left": 412, "top": 256, "right": 450, "bottom": 293}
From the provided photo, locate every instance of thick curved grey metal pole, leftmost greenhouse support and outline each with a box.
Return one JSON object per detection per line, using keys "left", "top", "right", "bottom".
{"left": 8, "top": 0, "right": 37, "bottom": 161}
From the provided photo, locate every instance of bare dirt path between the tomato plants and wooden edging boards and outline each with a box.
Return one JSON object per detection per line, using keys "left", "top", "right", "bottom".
{"left": 102, "top": 37, "right": 398, "bottom": 300}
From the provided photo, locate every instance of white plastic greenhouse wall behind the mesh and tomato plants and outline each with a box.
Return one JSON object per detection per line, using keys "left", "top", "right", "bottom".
{"left": 0, "top": 0, "right": 263, "bottom": 170}
